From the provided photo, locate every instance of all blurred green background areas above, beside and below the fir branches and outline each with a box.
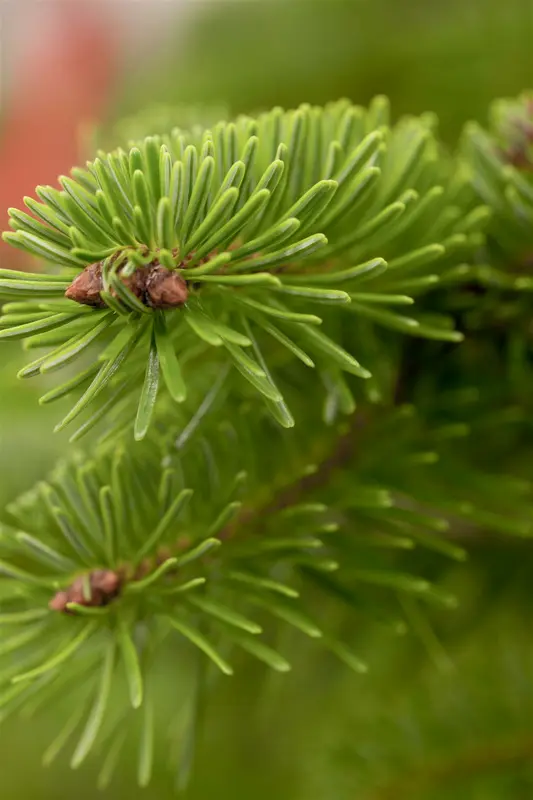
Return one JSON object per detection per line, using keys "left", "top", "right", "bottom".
{"left": 0, "top": 0, "right": 533, "bottom": 800}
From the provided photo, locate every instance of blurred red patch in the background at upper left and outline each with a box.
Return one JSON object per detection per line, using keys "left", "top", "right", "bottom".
{"left": 0, "top": 0, "right": 118, "bottom": 268}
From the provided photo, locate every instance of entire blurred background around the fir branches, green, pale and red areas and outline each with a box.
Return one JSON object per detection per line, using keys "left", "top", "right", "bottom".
{"left": 0, "top": 0, "right": 533, "bottom": 800}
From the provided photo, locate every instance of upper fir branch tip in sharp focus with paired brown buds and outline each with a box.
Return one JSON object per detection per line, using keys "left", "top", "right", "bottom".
{"left": 0, "top": 98, "right": 487, "bottom": 439}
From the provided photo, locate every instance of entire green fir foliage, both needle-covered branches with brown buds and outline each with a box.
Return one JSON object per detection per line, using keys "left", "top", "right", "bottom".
{"left": 0, "top": 97, "right": 533, "bottom": 789}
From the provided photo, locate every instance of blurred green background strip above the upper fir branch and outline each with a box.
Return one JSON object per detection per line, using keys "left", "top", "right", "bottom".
{"left": 117, "top": 0, "right": 533, "bottom": 141}
